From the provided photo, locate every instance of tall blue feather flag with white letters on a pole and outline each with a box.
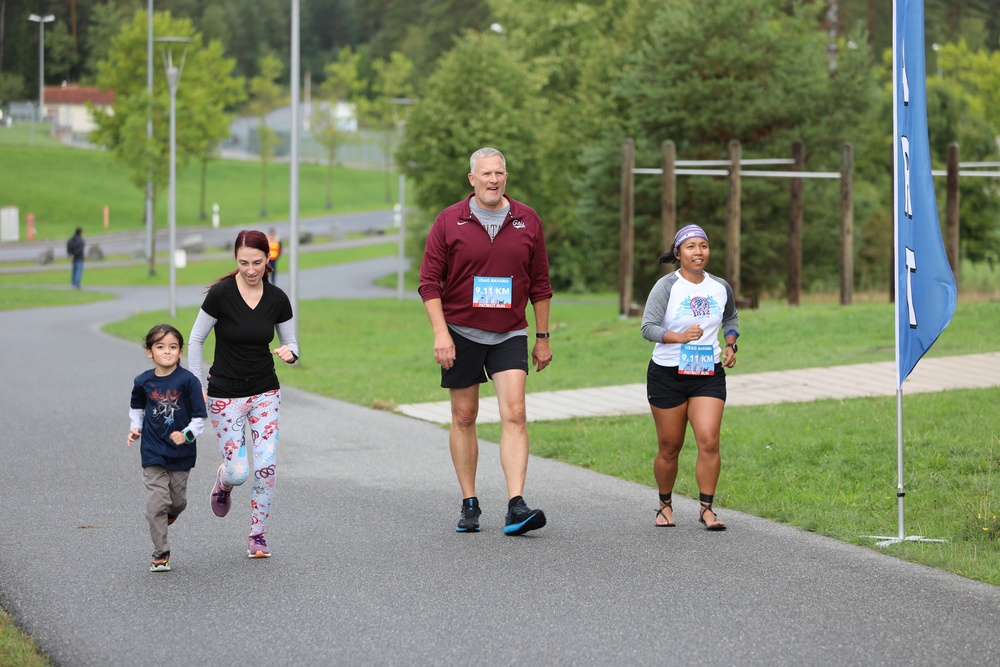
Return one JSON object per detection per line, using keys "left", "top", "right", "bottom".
{"left": 893, "top": 0, "right": 958, "bottom": 389}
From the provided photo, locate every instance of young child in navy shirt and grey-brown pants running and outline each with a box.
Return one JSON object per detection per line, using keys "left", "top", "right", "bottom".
{"left": 128, "top": 324, "right": 208, "bottom": 572}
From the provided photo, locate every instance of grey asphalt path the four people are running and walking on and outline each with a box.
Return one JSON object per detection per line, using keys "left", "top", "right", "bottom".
{"left": 0, "top": 260, "right": 1000, "bottom": 667}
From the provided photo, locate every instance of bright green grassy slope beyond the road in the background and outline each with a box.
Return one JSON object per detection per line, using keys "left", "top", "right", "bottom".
{"left": 0, "top": 138, "right": 396, "bottom": 240}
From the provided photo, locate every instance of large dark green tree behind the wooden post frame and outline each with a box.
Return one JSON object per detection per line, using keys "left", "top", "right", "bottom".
{"left": 587, "top": 0, "right": 877, "bottom": 293}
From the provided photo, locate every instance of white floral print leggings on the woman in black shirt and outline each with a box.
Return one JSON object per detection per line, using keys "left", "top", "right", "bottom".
{"left": 208, "top": 389, "right": 281, "bottom": 535}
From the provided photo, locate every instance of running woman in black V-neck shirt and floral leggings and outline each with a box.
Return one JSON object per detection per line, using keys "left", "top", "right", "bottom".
{"left": 188, "top": 231, "right": 299, "bottom": 558}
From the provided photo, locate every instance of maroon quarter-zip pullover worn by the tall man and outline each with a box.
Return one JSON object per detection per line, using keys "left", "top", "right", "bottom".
{"left": 419, "top": 195, "right": 552, "bottom": 333}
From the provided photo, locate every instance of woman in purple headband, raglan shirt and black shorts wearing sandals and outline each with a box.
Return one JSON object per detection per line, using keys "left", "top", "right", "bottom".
{"left": 642, "top": 225, "right": 740, "bottom": 530}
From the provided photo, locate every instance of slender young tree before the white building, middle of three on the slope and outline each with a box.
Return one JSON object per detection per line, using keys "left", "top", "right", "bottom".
{"left": 312, "top": 47, "right": 364, "bottom": 209}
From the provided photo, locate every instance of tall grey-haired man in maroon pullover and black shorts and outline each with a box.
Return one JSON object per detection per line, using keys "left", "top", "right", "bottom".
{"left": 420, "top": 148, "right": 552, "bottom": 535}
